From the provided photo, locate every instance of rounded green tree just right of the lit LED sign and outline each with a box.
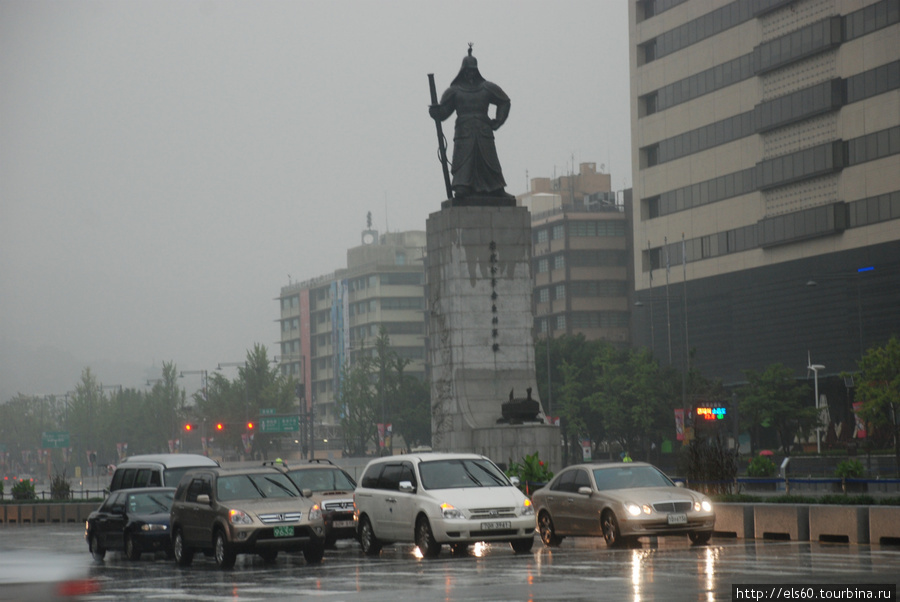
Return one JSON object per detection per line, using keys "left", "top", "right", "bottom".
{"left": 738, "top": 363, "right": 818, "bottom": 455}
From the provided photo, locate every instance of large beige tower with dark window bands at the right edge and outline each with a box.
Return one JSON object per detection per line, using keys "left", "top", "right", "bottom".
{"left": 629, "top": 0, "right": 900, "bottom": 384}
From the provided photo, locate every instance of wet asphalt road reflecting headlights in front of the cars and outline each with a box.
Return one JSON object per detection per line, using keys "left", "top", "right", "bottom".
{"left": 0, "top": 524, "right": 900, "bottom": 602}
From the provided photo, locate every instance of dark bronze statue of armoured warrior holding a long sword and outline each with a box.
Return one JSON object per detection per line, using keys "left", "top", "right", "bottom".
{"left": 428, "top": 44, "right": 514, "bottom": 199}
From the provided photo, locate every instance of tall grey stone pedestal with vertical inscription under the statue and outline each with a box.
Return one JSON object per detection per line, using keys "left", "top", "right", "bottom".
{"left": 426, "top": 203, "right": 561, "bottom": 470}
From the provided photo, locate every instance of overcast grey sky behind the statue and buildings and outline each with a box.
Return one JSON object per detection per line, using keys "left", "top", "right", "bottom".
{"left": 0, "top": 0, "right": 631, "bottom": 402}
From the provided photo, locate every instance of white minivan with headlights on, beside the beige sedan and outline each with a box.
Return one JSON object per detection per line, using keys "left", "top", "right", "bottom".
{"left": 353, "top": 453, "right": 535, "bottom": 558}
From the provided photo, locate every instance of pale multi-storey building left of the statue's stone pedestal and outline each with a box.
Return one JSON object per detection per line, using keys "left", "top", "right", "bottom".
{"left": 278, "top": 230, "right": 425, "bottom": 446}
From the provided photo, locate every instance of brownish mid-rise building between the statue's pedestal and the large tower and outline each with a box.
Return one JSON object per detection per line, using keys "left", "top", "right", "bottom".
{"left": 518, "top": 163, "right": 630, "bottom": 345}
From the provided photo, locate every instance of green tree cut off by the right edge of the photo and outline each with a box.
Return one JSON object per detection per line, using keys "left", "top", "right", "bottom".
{"left": 855, "top": 335, "right": 900, "bottom": 475}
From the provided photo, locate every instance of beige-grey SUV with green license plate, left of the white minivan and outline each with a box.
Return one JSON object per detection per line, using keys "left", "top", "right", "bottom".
{"left": 169, "top": 467, "right": 325, "bottom": 569}
